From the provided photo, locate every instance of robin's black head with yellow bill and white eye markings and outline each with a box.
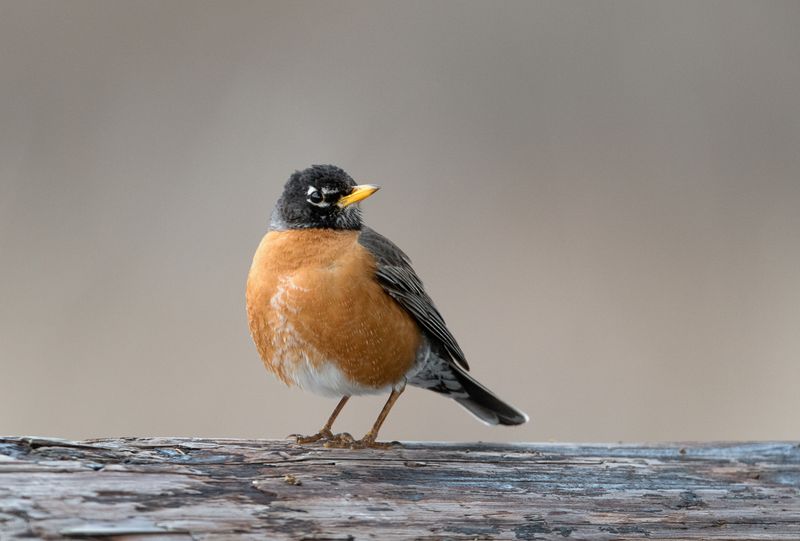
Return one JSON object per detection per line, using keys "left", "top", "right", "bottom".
{"left": 270, "top": 165, "right": 378, "bottom": 230}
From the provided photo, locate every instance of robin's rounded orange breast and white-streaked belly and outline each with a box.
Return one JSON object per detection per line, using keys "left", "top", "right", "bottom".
{"left": 247, "top": 229, "right": 421, "bottom": 394}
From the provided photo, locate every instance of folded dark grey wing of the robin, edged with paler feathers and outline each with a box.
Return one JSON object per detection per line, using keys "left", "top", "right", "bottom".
{"left": 358, "top": 226, "right": 469, "bottom": 370}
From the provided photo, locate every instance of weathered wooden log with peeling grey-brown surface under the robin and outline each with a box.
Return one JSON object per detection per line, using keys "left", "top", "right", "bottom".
{"left": 0, "top": 438, "right": 800, "bottom": 541}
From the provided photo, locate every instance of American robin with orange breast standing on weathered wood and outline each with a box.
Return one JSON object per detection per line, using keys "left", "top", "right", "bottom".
{"left": 247, "top": 165, "right": 528, "bottom": 447}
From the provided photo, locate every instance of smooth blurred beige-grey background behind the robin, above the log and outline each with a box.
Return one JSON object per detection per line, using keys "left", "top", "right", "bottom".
{"left": 0, "top": 0, "right": 800, "bottom": 440}
